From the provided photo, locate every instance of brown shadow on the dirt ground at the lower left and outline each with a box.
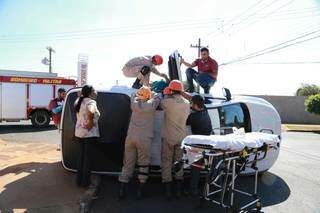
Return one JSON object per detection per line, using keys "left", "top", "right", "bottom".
{"left": 0, "top": 162, "right": 84, "bottom": 212}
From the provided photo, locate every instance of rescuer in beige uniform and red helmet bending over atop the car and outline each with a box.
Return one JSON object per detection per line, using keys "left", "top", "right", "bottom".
{"left": 122, "top": 55, "right": 169, "bottom": 89}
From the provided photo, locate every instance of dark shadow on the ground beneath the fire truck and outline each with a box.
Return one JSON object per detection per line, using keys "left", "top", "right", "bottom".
{"left": 0, "top": 124, "right": 57, "bottom": 134}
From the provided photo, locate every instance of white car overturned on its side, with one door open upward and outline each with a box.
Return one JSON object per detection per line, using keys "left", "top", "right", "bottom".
{"left": 61, "top": 52, "right": 281, "bottom": 174}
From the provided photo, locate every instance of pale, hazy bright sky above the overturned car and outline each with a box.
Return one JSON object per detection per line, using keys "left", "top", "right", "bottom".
{"left": 0, "top": 0, "right": 320, "bottom": 95}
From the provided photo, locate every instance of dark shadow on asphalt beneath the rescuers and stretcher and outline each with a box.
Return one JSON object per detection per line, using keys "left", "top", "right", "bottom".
{"left": 92, "top": 172, "right": 290, "bottom": 213}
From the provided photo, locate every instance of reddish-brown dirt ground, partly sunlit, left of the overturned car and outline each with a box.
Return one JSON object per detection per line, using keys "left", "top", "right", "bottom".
{"left": 0, "top": 139, "right": 85, "bottom": 212}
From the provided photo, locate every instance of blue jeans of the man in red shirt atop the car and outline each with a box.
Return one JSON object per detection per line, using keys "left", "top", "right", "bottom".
{"left": 186, "top": 68, "right": 216, "bottom": 94}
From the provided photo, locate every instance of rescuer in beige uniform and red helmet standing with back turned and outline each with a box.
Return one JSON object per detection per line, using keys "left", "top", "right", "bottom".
{"left": 160, "top": 80, "right": 190, "bottom": 199}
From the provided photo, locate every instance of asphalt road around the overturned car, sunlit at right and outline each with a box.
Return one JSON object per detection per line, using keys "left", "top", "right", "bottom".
{"left": 0, "top": 122, "right": 320, "bottom": 213}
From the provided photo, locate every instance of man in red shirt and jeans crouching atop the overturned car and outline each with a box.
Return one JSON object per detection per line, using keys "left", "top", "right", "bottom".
{"left": 181, "top": 47, "right": 218, "bottom": 94}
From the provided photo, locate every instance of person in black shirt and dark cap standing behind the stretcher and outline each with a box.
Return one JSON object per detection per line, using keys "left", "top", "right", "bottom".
{"left": 187, "top": 95, "right": 212, "bottom": 196}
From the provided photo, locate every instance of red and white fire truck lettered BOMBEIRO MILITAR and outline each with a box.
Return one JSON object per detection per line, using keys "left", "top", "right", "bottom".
{"left": 0, "top": 70, "right": 76, "bottom": 127}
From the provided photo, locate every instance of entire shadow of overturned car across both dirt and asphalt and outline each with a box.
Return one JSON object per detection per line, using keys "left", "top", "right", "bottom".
{"left": 0, "top": 162, "right": 290, "bottom": 213}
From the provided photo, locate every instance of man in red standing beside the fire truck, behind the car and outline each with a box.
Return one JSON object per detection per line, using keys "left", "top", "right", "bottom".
{"left": 48, "top": 88, "right": 66, "bottom": 128}
